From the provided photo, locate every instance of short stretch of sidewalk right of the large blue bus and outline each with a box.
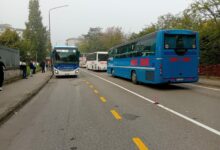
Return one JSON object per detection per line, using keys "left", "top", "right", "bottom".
{"left": 198, "top": 76, "right": 220, "bottom": 88}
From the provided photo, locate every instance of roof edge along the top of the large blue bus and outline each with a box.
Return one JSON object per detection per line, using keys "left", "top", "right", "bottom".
{"left": 110, "top": 29, "right": 196, "bottom": 50}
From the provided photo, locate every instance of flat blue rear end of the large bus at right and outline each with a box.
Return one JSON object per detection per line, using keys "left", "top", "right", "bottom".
{"left": 162, "top": 34, "right": 198, "bottom": 82}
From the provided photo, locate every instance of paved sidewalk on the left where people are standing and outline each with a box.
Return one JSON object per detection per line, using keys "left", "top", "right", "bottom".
{"left": 0, "top": 71, "right": 52, "bottom": 123}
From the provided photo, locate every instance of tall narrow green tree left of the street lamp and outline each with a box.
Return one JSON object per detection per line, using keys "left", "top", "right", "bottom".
{"left": 24, "top": 0, "right": 48, "bottom": 61}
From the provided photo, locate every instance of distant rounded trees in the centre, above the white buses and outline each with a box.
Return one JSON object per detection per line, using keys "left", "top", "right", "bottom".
{"left": 77, "top": 27, "right": 125, "bottom": 53}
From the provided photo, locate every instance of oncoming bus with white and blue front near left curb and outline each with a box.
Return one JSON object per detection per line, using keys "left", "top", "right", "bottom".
{"left": 51, "top": 46, "right": 80, "bottom": 76}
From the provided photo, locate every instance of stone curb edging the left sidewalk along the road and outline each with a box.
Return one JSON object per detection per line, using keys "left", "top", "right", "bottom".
{"left": 0, "top": 75, "right": 53, "bottom": 126}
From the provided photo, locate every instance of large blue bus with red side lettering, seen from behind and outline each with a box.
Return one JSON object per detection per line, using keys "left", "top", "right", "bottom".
{"left": 107, "top": 29, "right": 199, "bottom": 84}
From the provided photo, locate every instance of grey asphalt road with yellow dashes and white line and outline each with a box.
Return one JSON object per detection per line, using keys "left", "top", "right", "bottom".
{"left": 0, "top": 69, "right": 220, "bottom": 150}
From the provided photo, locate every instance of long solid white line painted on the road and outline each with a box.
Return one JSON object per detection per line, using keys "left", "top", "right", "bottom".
{"left": 83, "top": 70, "right": 220, "bottom": 136}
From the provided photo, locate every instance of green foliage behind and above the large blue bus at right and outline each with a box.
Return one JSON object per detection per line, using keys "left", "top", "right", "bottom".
{"left": 130, "top": 0, "right": 220, "bottom": 64}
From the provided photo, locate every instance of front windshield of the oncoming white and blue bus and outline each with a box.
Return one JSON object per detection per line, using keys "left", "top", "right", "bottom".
{"left": 55, "top": 49, "right": 79, "bottom": 63}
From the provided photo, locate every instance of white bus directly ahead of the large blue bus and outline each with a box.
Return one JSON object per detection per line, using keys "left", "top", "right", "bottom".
{"left": 86, "top": 52, "right": 108, "bottom": 71}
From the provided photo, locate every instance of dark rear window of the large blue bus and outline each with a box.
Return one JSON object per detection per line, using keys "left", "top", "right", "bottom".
{"left": 164, "top": 34, "right": 196, "bottom": 49}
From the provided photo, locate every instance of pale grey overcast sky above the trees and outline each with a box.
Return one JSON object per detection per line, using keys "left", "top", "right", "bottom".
{"left": 0, "top": 0, "right": 193, "bottom": 44}
